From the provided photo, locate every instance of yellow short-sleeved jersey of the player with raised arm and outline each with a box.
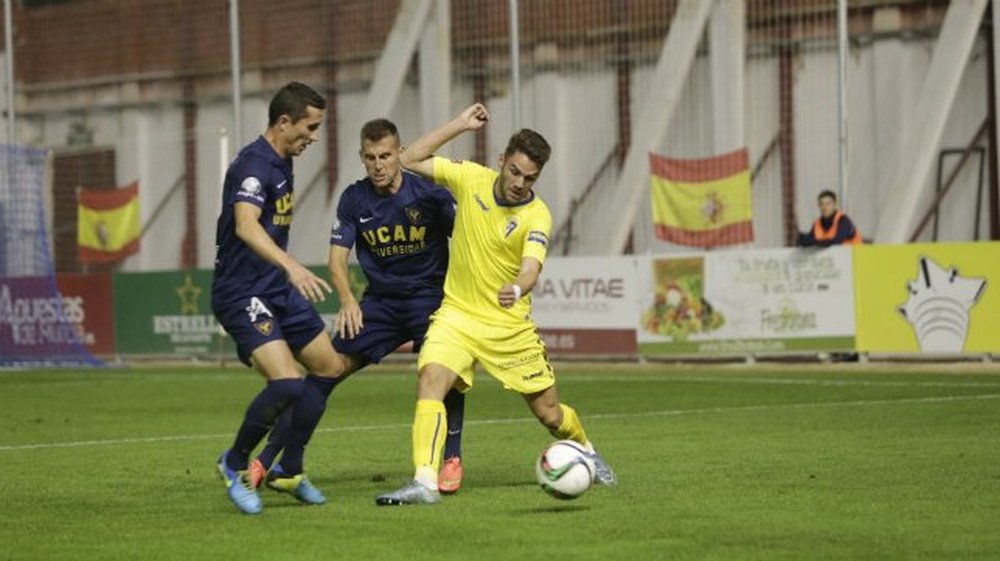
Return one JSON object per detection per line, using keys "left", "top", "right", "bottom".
{"left": 433, "top": 158, "right": 552, "bottom": 324}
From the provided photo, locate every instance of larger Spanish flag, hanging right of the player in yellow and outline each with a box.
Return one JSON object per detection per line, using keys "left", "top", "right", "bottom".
{"left": 649, "top": 148, "right": 753, "bottom": 248}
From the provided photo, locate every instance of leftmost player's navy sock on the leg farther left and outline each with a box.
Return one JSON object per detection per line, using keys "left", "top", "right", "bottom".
{"left": 226, "top": 378, "right": 303, "bottom": 471}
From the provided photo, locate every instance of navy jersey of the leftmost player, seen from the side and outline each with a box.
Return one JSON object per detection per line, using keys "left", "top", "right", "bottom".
{"left": 212, "top": 136, "right": 294, "bottom": 308}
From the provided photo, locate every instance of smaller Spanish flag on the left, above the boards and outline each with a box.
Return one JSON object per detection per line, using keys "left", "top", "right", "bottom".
{"left": 76, "top": 182, "right": 140, "bottom": 263}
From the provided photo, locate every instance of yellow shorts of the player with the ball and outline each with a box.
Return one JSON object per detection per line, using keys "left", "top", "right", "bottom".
{"left": 417, "top": 308, "right": 555, "bottom": 394}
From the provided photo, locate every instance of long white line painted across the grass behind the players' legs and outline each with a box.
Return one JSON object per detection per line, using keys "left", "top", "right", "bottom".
{"left": 0, "top": 394, "right": 1000, "bottom": 452}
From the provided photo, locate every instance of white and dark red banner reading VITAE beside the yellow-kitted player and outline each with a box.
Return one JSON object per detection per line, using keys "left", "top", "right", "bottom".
{"left": 531, "top": 257, "right": 639, "bottom": 355}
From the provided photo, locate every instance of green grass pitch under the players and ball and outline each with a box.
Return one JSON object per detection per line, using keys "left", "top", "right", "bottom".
{"left": 0, "top": 364, "right": 1000, "bottom": 561}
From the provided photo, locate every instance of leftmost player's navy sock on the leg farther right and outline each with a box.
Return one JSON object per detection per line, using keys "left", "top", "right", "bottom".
{"left": 274, "top": 374, "right": 343, "bottom": 475}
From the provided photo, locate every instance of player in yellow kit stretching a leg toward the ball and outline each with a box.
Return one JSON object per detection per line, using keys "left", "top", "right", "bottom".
{"left": 375, "top": 103, "right": 616, "bottom": 505}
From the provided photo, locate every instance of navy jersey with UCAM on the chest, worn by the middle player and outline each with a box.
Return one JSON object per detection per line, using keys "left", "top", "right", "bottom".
{"left": 330, "top": 172, "right": 455, "bottom": 298}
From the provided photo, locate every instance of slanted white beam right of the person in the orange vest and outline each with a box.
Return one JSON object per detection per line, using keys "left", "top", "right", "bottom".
{"left": 875, "top": 0, "right": 986, "bottom": 243}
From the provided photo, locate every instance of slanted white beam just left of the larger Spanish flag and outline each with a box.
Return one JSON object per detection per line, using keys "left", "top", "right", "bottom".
{"left": 597, "top": 0, "right": 714, "bottom": 255}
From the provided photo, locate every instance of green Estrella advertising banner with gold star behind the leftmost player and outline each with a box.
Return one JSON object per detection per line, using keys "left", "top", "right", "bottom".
{"left": 113, "top": 265, "right": 366, "bottom": 356}
